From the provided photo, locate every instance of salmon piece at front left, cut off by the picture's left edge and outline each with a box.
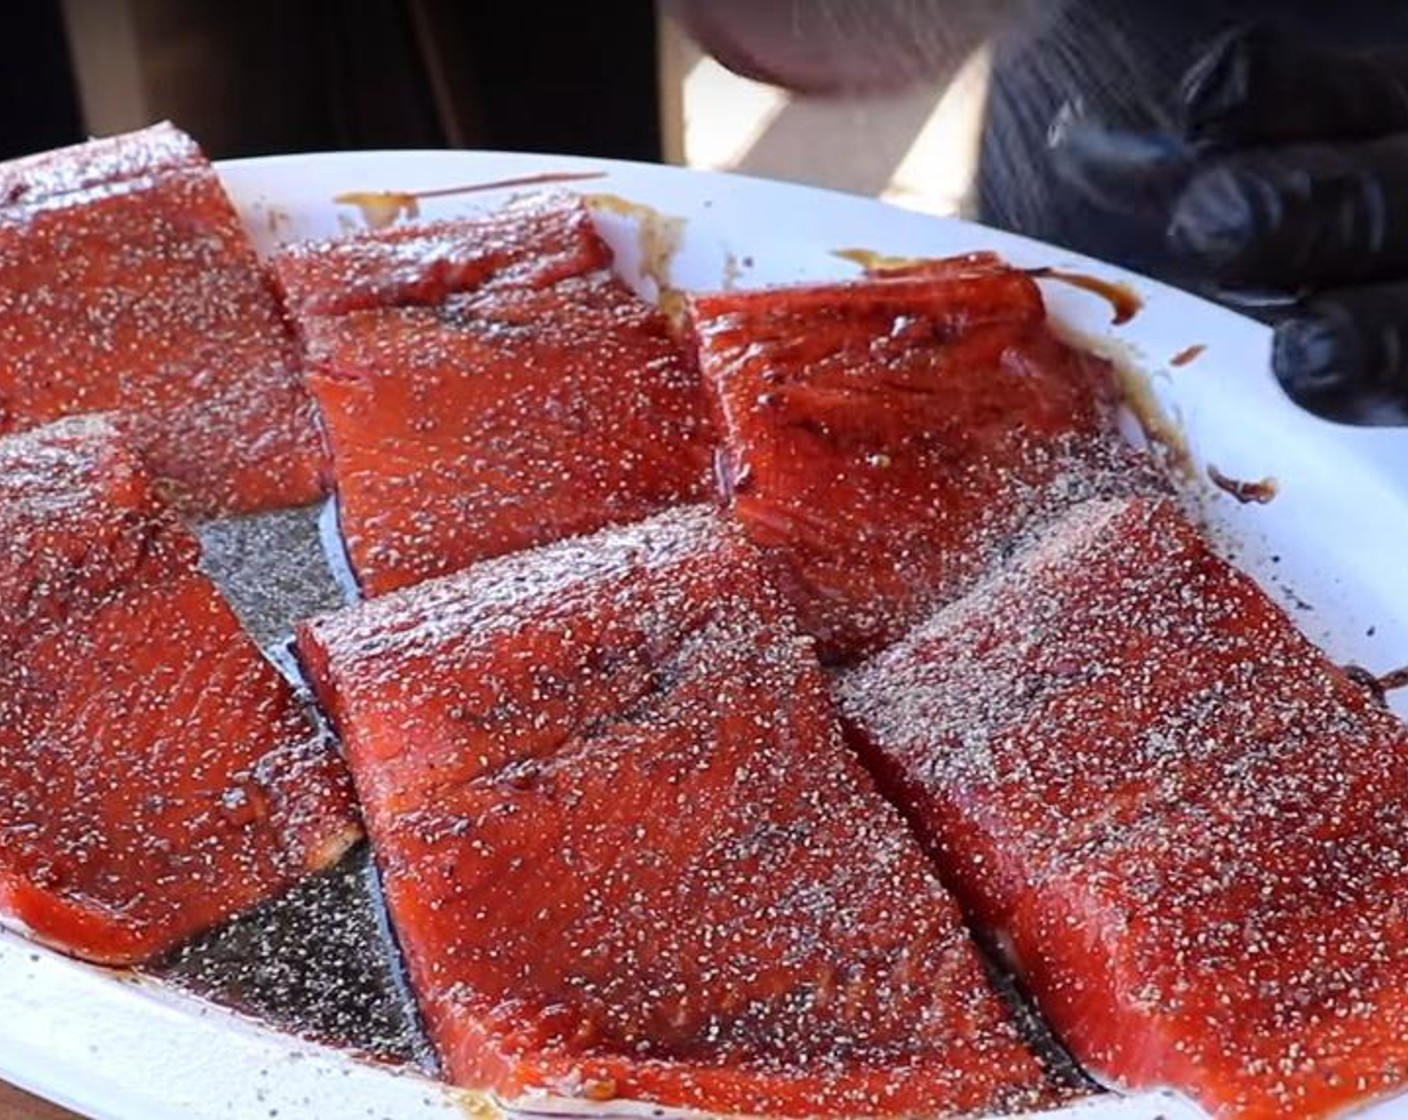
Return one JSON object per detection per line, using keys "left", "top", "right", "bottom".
{"left": 0, "top": 416, "right": 359, "bottom": 964}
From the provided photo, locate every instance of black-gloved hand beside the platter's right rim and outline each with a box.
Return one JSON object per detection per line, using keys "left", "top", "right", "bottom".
{"left": 1050, "top": 28, "right": 1408, "bottom": 424}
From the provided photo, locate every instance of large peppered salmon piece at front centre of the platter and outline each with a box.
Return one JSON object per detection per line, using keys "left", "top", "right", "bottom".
{"left": 298, "top": 507, "right": 1055, "bottom": 1116}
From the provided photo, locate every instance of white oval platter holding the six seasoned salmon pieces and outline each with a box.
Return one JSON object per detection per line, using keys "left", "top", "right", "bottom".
{"left": 0, "top": 152, "right": 1408, "bottom": 1120}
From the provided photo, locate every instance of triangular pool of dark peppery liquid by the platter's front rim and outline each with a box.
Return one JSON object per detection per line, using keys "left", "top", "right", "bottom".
{"left": 148, "top": 844, "right": 434, "bottom": 1071}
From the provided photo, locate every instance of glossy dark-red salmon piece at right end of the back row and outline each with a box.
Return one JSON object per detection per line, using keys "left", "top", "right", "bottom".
{"left": 690, "top": 255, "right": 1132, "bottom": 661}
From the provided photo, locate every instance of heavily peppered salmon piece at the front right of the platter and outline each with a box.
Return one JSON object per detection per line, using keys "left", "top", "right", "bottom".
{"left": 841, "top": 499, "right": 1408, "bottom": 1117}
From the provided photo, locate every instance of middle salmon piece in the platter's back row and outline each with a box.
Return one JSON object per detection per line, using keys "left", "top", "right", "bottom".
{"left": 277, "top": 197, "right": 712, "bottom": 596}
